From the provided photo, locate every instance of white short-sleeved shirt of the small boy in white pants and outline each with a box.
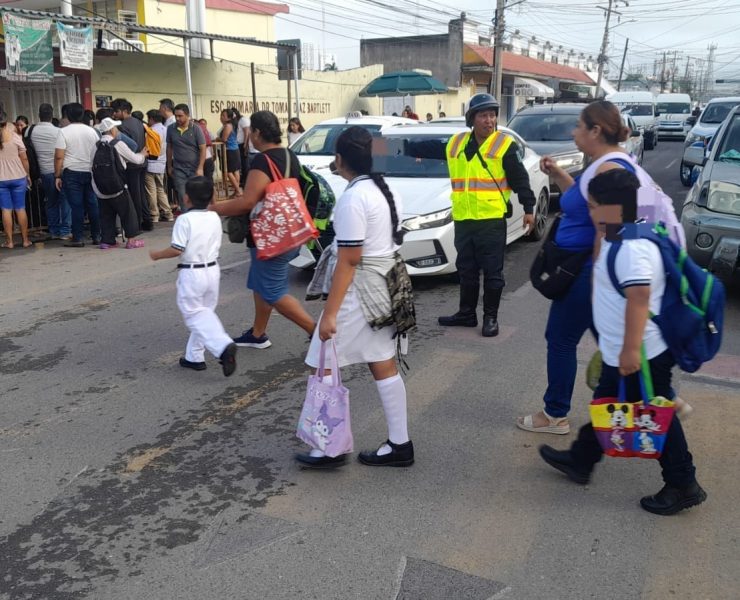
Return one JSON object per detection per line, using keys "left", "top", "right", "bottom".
{"left": 170, "top": 210, "right": 223, "bottom": 264}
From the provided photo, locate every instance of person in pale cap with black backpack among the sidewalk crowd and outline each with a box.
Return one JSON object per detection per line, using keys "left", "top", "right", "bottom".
{"left": 90, "top": 117, "right": 147, "bottom": 250}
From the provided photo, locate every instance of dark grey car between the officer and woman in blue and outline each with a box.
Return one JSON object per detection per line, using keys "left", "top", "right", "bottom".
{"left": 506, "top": 104, "right": 586, "bottom": 194}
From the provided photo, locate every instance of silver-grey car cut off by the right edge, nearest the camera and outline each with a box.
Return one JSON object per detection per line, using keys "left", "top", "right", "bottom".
{"left": 681, "top": 106, "right": 740, "bottom": 276}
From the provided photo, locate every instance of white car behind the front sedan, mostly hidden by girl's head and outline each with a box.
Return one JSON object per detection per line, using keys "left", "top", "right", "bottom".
{"left": 290, "top": 113, "right": 419, "bottom": 169}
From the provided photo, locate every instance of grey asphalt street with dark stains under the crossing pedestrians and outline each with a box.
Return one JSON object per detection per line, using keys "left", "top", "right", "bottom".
{"left": 0, "top": 141, "right": 740, "bottom": 600}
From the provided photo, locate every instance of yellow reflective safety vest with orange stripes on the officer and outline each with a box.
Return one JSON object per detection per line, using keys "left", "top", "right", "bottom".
{"left": 447, "top": 131, "right": 514, "bottom": 221}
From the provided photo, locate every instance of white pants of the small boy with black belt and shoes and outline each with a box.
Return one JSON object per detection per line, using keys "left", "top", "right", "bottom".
{"left": 177, "top": 265, "right": 234, "bottom": 362}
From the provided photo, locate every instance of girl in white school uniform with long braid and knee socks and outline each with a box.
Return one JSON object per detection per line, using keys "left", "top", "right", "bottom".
{"left": 296, "top": 127, "right": 414, "bottom": 468}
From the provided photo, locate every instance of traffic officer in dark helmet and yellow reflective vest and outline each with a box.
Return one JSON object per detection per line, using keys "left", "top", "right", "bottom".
{"left": 439, "top": 94, "right": 535, "bottom": 337}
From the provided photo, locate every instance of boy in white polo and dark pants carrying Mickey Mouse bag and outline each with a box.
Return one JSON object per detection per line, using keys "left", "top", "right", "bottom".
{"left": 540, "top": 169, "right": 707, "bottom": 515}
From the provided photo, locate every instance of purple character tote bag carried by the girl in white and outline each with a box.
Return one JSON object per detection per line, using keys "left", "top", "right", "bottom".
{"left": 296, "top": 340, "right": 353, "bottom": 457}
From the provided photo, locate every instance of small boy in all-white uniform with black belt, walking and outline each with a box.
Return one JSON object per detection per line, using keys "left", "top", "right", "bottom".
{"left": 149, "top": 176, "right": 236, "bottom": 377}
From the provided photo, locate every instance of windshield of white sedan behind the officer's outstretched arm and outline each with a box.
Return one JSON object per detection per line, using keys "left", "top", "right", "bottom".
{"left": 373, "top": 133, "right": 452, "bottom": 178}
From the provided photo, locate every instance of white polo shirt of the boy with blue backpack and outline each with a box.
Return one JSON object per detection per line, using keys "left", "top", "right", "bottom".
{"left": 593, "top": 239, "right": 668, "bottom": 367}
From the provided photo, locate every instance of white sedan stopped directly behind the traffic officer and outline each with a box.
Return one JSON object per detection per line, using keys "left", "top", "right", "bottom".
{"left": 291, "top": 124, "right": 549, "bottom": 275}
